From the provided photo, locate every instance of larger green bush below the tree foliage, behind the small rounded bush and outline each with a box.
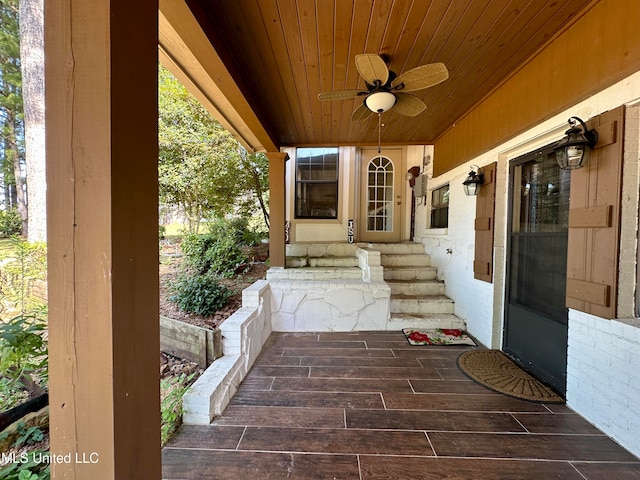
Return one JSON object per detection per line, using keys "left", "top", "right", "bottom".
{"left": 181, "top": 219, "right": 248, "bottom": 276}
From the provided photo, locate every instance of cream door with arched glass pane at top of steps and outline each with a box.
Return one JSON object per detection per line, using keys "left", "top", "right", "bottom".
{"left": 359, "top": 148, "right": 405, "bottom": 242}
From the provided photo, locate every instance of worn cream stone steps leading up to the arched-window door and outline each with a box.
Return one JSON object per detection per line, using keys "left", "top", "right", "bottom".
{"left": 368, "top": 243, "right": 465, "bottom": 329}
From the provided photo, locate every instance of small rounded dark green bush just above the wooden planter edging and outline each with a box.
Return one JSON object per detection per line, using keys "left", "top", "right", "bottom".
{"left": 169, "top": 272, "right": 233, "bottom": 316}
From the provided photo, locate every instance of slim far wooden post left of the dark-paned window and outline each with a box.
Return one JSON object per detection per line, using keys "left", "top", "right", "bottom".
{"left": 266, "top": 152, "right": 289, "bottom": 267}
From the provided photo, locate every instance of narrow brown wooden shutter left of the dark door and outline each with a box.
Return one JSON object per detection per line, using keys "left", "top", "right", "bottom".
{"left": 473, "top": 162, "right": 497, "bottom": 283}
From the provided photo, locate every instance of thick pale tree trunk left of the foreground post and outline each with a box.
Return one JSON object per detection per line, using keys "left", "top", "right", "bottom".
{"left": 20, "top": 0, "right": 47, "bottom": 242}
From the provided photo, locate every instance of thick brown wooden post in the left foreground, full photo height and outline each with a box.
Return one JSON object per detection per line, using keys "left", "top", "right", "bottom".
{"left": 45, "top": 0, "right": 161, "bottom": 480}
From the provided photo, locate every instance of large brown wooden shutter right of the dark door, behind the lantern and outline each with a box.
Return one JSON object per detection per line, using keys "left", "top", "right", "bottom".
{"left": 567, "top": 107, "right": 624, "bottom": 319}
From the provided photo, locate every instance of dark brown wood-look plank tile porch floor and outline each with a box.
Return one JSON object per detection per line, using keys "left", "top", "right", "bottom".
{"left": 163, "top": 332, "right": 640, "bottom": 480}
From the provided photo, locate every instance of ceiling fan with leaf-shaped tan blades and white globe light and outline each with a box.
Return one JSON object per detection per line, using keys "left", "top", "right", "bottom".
{"left": 318, "top": 53, "right": 449, "bottom": 122}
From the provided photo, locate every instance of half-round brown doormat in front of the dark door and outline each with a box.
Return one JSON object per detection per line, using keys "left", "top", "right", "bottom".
{"left": 458, "top": 350, "right": 564, "bottom": 403}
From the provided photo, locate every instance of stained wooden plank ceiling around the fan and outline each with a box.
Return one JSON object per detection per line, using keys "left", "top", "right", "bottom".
{"left": 187, "top": 0, "right": 593, "bottom": 146}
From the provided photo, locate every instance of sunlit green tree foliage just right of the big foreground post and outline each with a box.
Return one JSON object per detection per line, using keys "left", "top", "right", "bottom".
{"left": 158, "top": 66, "right": 268, "bottom": 231}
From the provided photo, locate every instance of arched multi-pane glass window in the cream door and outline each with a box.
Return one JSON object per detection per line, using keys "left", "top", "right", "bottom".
{"left": 367, "top": 156, "right": 395, "bottom": 232}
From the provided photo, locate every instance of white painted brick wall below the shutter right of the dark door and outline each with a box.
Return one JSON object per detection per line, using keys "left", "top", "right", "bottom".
{"left": 567, "top": 310, "right": 640, "bottom": 455}
